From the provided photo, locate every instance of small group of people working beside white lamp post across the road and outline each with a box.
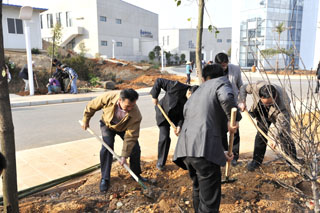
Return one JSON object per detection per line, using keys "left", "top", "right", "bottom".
{"left": 19, "top": 59, "right": 78, "bottom": 95}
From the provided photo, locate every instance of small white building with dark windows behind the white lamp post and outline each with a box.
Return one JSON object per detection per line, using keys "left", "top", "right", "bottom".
{"left": 2, "top": 3, "right": 47, "bottom": 49}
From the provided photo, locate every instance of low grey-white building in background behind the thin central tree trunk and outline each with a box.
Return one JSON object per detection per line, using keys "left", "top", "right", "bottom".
{"left": 159, "top": 28, "right": 231, "bottom": 61}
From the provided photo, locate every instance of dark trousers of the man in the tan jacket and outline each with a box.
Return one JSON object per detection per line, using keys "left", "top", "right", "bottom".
{"left": 100, "top": 121, "right": 141, "bottom": 181}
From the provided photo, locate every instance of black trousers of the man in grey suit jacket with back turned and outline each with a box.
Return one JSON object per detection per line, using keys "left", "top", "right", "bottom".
{"left": 183, "top": 157, "right": 221, "bottom": 213}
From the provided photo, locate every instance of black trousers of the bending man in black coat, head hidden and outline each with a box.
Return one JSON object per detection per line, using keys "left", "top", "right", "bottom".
{"left": 157, "top": 122, "right": 171, "bottom": 166}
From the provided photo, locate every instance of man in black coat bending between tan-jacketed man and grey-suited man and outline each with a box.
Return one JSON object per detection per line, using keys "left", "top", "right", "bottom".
{"left": 150, "top": 78, "right": 198, "bottom": 170}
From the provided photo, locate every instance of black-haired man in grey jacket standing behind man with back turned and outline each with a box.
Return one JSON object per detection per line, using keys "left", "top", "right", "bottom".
{"left": 214, "top": 53, "right": 243, "bottom": 166}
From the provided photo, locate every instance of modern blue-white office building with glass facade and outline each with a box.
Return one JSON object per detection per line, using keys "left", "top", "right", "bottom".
{"left": 231, "top": 0, "right": 320, "bottom": 69}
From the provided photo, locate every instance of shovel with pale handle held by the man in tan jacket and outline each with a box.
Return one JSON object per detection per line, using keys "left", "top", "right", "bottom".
{"left": 79, "top": 120, "right": 156, "bottom": 200}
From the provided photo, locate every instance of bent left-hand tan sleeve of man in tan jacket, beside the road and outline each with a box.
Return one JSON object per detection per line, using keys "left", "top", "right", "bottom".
{"left": 82, "top": 93, "right": 111, "bottom": 124}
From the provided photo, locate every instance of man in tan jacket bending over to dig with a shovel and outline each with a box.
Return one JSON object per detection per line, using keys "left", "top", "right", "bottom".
{"left": 82, "top": 89, "right": 147, "bottom": 192}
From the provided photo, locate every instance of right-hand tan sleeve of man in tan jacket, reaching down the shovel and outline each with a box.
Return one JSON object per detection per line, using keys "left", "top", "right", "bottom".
{"left": 121, "top": 115, "right": 142, "bottom": 157}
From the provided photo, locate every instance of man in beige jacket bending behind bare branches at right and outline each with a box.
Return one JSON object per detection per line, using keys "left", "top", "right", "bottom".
{"left": 238, "top": 81, "right": 297, "bottom": 171}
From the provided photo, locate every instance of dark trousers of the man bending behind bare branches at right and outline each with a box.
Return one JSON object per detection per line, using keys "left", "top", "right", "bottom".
{"left": 250, "top": 103, "right": 297, "bottom": 164}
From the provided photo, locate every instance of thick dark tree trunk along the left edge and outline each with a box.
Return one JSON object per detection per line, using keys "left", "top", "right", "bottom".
{"left": 0, "top": 0, "right": 19, "bottom": 213}
